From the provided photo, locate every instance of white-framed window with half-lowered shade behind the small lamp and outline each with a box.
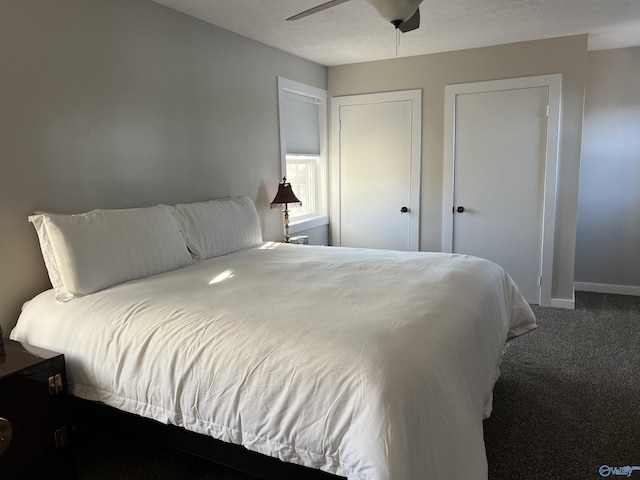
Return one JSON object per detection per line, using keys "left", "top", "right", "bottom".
{"left": 278, "top": 77, "right": 329, "bottom": 233}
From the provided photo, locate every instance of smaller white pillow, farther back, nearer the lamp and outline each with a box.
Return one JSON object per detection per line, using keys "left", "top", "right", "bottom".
{"left": 174, "top": 196, "right": 262, "bottom": 260}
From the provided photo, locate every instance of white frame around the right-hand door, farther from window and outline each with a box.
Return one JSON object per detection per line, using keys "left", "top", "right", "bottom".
{"left": 442, "top": 73, "right": 562, "bottom": 306}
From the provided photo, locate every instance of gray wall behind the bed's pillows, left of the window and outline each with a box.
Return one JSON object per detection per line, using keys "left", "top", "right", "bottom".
{"left": 0, "top": 0, "right": 326, "bottom": 335}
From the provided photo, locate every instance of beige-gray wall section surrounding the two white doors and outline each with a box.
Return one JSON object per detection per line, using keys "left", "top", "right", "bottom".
{"left": 328, "top": 35, "right": 587, "bottom": 307}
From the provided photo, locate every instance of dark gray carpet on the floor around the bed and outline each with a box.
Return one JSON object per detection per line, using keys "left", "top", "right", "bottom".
{"left": 76, "top": 292, "right": 640, "bottom": 480}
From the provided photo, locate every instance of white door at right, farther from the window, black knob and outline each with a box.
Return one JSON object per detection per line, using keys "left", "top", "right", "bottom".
{"left": 448, "top": 77, "right": 555, "bottom": 304}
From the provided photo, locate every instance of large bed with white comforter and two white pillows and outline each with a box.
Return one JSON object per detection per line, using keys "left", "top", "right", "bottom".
{"left": 11, "top": 197, "right": 536, "bottom": 480}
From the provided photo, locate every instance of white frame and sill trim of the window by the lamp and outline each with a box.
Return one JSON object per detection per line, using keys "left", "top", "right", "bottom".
{"left": 278, "top": 77, "right": 329, "bottom": 233}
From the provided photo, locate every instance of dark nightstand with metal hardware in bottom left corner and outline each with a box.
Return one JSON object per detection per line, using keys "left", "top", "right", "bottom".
{"left": 0, "top": 339, "right": 74, "bottom": 480}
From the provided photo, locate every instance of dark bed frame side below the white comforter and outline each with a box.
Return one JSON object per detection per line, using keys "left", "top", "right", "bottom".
{"left": 71, "top": 397, "right": 346, "bottom": 480}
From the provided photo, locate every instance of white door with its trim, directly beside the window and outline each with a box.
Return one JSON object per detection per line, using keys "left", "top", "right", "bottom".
{"left": 332, "top": 91, "right": 421, "bottom": 250}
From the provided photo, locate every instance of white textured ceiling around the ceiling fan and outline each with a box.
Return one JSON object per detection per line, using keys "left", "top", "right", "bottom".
{"left": 154, "top": 0, "right": 640, "bottom": 66}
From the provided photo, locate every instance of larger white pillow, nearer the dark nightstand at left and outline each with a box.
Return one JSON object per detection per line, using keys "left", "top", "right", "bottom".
{"left": 29, "top": 205, "right": 193, "bottom": 301}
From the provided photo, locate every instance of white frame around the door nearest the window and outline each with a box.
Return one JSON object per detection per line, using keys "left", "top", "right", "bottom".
{"left": 329, "top": 89, "right": 422, "bottom": 251}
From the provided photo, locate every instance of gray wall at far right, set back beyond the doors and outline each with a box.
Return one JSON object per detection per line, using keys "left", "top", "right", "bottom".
{"left": 576, "top": 48, "right": 640, "bottom": 295}
